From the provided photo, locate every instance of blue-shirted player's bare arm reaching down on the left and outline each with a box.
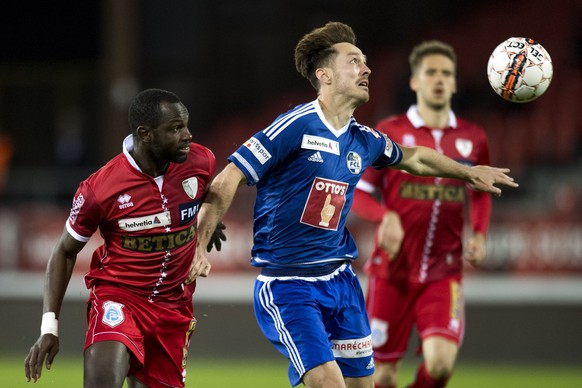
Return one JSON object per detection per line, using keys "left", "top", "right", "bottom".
{"left": 184, "top": 163, "right": 247, "bottom": 284}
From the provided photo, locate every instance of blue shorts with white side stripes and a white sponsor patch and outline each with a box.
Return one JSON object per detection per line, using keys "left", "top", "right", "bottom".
{"left": 255, "top": 264, "right": 374, "bottom": 386}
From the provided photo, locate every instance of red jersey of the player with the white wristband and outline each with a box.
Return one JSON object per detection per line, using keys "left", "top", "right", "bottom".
{"left": 66, "top": 135, "right": 216, "bottom": 306}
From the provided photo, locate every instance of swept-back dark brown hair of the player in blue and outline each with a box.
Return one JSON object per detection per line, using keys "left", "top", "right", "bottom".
{"left": 295, "top": 22, "right": 356, "bottom": 90}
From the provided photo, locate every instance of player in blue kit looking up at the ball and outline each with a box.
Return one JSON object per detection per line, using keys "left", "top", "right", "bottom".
{"left": 187, "top": 22, "right": 517, "bottom": 388}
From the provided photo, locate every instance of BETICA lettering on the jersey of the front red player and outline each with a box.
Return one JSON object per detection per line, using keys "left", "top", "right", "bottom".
{"left": 121, "top": 225, "right": 196, "bottom": 252}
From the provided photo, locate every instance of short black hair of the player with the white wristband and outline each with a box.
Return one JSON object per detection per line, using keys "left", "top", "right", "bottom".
{"left": 128, "top": 89, "right": 182, "bottom": 132}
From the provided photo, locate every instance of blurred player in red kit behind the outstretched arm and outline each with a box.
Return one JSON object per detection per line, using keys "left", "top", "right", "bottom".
{"left": 352, "top": 41, "right": 491, "bottom": 387}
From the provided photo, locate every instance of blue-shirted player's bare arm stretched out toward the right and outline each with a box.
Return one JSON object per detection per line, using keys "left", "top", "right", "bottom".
{"left": 395, "top": 146, "right": 519, "bottom": 196}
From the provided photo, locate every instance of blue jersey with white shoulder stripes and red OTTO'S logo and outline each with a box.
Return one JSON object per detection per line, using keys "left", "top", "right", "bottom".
{"left": 228, "top": 100, "right": 402, "bottom": 273}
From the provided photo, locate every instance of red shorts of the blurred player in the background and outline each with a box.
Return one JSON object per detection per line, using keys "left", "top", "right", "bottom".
{"left": 367, "top": 276, "right": 465, "bottom": 362}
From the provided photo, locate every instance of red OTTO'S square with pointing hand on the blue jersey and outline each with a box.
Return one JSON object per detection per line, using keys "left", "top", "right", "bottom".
{"left": 300, "top": 177, "right": 349, "bottom": 230}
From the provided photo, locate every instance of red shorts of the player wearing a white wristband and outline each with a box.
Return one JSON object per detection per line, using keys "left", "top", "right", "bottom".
{"left": 85, "top": 286, "right": 196, "bottom": 388}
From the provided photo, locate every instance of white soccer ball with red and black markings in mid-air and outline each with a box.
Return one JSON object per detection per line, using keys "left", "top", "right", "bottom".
{"left": 487, "top": 38, "right": 554, "bottom": 103}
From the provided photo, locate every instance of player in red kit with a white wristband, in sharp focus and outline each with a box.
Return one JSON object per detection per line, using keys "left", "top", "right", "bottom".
{"left": 25, "top": 89, "right": 218, "bottom": 388}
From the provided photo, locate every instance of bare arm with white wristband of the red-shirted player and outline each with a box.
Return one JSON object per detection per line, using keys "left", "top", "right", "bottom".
{"left": 24, "top": 229, "right": 85, "bottom": 382}
